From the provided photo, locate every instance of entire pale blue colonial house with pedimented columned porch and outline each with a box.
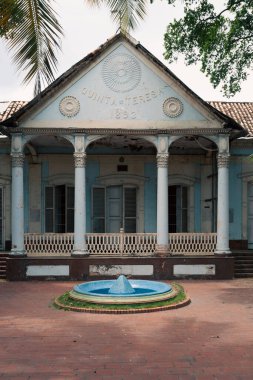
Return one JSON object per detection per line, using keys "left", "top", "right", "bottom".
{"left": 0, "top": 34, "right": 253, "bottom": 280}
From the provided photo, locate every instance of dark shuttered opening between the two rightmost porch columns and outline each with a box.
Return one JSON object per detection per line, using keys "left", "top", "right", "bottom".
{"left": 169, "top": 186, "right": 188, "bottom": 232}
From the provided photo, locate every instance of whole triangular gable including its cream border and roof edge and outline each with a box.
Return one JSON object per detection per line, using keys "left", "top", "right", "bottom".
{"left": 2, "top": 36, "right": 243, "bottom": 134}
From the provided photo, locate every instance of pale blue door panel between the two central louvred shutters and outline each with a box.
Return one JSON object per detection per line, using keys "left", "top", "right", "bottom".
{"left": 106, "top": 186, "right": 123, "bottom": 232}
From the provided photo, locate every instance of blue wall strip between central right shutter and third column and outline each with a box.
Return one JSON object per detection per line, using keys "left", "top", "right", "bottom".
{"left": 144, "top": 162, "right": 157, "bottom": 232}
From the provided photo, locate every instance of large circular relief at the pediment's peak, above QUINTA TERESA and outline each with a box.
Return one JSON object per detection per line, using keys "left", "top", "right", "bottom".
{"left": 102, "top": 54, "right": 141, "bottom": 92}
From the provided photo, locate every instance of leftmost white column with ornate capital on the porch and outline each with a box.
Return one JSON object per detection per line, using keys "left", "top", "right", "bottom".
{"left": 11, "top": 152, "right": 26, "bottom": 256}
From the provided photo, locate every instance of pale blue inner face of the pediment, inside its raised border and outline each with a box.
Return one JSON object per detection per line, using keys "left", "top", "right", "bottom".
{"left": 34, "top": 44, "right": 210, "bottom": 121}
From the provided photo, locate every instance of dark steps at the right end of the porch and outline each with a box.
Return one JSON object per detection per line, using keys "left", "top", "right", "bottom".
{"left": 234, "top": 251, "right": 253, "bottom": 278}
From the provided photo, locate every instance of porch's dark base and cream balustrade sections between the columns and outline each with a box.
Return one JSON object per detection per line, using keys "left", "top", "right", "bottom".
{"left": 7, "top": 230, "right": 234, "bottom": 281}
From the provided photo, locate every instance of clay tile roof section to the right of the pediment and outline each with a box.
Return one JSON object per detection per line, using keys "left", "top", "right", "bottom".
{"left": 208, "top": 101, "right": 253, "bottom": 135}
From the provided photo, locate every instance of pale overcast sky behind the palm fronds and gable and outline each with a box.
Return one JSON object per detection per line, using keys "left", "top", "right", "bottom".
{"left": 0, "top": 0, "right": 253, "bottom": 102}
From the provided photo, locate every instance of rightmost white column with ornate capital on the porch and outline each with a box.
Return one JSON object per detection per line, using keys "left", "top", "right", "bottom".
{"left": 215, "top": 152, "right": 231, "bottom": 255}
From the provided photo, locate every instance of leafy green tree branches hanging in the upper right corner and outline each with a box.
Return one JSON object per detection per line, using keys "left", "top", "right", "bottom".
{"left": 164, "top": 0, "right": 253, "bottom": 97}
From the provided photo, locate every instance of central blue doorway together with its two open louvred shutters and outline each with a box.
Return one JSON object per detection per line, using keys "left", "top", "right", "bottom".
{"left": 93, "top": 186, "right": 137, "bottom": 233}
